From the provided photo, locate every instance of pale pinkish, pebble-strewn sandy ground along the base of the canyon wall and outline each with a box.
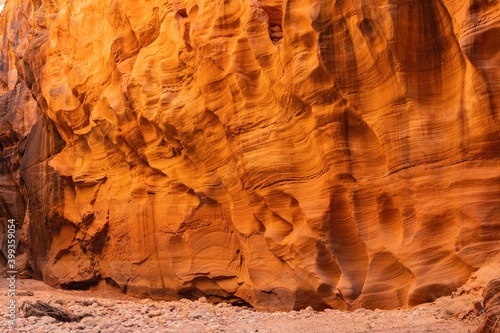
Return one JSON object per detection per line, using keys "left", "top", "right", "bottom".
{"left": 0, "top": 278, "right": 482, "bottom": 333}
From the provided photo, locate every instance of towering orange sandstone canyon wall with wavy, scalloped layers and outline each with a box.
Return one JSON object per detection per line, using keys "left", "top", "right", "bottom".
{"left": 0, "top": 0, "right": 500, "bottom": 310}
